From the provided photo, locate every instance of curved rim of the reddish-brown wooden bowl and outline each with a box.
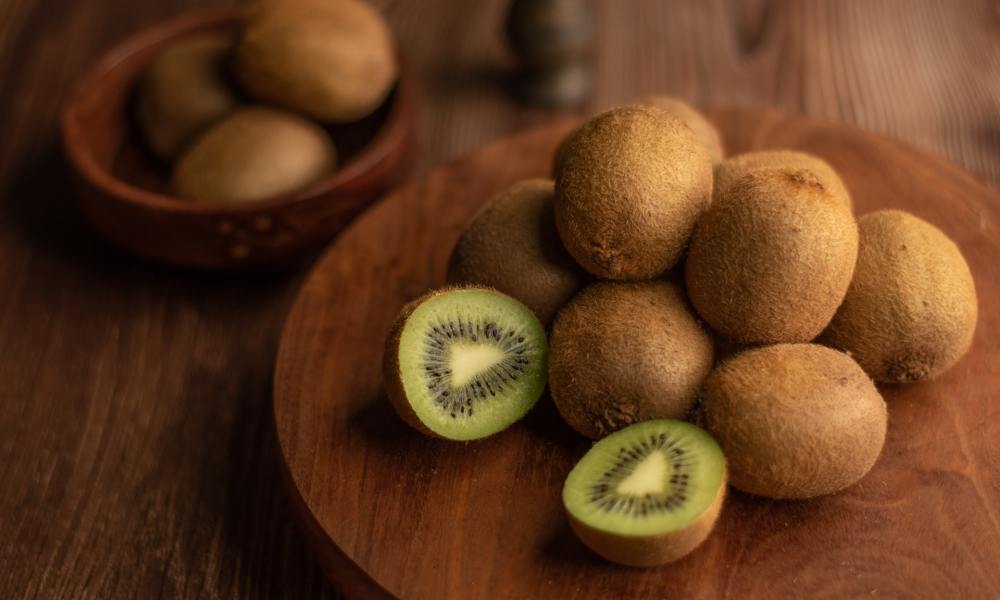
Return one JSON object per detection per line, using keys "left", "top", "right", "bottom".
{"left": 60, "top": 7, "right": 413, "bottom": 215}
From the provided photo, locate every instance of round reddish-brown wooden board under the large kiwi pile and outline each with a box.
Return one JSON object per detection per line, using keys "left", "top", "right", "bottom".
{"left": 274, "top": 111, "right": 1000, "bottom": 600}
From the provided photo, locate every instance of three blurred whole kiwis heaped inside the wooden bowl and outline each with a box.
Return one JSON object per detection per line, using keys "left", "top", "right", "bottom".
{"left": 134, "top": 0, "right": 399, "bottom": 205}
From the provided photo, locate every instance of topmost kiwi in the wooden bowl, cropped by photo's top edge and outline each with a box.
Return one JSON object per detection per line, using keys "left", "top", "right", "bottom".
{"left": 235, "top": 0, "right": 399, "bottom": 123}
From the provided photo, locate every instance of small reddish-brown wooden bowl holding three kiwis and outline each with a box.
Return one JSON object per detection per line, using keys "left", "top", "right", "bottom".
{"left": 62, "top": 9, "right": 413, "bottom": 268}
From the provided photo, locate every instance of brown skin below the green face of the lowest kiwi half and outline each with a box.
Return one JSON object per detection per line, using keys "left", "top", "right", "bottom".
{"left": 566, "top": 468, "right": 726, "bottom": 567}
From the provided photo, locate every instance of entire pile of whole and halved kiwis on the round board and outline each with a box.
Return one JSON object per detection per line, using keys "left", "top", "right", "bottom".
{"left": 383, "top": 97, "right": 977, "bottom": 567}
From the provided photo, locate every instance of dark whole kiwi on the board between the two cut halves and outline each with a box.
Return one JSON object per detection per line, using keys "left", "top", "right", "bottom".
{"left": 549, "top": 280, "right": 713, "bottom": 439}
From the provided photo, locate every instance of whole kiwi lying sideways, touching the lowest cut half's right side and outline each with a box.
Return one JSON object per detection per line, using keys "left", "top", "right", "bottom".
{"left": 702, "top": 344, "right": 887, "bottom": 499}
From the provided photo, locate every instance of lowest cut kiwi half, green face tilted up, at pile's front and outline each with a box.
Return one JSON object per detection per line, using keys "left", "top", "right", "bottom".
{"left": 563, "top": 420, "right": 726, "bottom": 567}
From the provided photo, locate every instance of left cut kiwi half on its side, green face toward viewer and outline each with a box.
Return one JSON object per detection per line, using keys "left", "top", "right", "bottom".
{"left": 382, "top": 287, "right": 548, "bottom": 440}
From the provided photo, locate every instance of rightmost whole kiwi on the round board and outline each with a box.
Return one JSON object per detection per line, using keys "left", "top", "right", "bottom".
{"left": 820, "top": 210, "right": 978, "bottom": 383}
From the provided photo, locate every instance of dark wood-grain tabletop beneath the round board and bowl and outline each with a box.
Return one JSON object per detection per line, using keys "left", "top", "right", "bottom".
{"left": 0, "top": 0, "right": 1000, "bottom": 598}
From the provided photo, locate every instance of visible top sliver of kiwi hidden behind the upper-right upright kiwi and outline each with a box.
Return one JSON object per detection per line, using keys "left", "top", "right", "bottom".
{"left": 713, "top": 150, "right": 853, "bottom": 208}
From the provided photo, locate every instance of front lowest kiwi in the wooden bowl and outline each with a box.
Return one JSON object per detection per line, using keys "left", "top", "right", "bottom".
{"left": 171, "top": 106, "right": 337, "bottom": 204}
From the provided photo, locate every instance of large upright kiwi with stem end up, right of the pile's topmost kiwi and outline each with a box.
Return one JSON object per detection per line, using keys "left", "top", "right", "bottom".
{"left": 685, "top": 168, "right": 858, "bottom": 344}
